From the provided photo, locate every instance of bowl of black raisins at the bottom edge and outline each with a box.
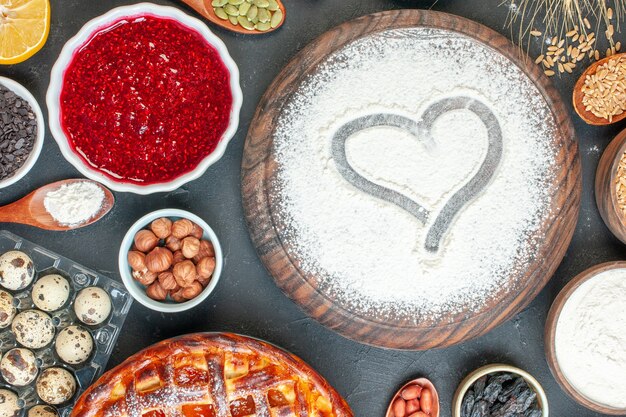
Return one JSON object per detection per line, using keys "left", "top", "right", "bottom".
{"left": 452, "top": 364, "right": 549, "bottom": 417}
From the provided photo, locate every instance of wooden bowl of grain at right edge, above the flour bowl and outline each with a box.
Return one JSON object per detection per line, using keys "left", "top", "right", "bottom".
{"left": 595, "top": 129, "right": 626, "bottom": 243}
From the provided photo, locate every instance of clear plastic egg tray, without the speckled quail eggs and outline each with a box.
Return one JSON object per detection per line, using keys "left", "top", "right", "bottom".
{"left": 0, "top": 230, "right": 133, "bottom": 417}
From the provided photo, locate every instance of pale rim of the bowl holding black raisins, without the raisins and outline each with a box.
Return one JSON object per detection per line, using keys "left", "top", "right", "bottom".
{"left": 452, "top": 363, "right": 550, "bottom": 417}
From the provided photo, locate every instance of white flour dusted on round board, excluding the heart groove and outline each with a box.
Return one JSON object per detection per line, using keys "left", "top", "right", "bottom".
{"left": 271, "top": 29, "right": 557, "bottom": 323}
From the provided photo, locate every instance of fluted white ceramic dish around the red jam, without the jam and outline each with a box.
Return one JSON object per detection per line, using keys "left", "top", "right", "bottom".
{"left": 46, "top": 3, "right": 243, "bottom": 194}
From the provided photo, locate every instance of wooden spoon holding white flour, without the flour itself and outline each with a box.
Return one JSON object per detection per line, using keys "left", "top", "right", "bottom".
{"left": 0, "top": 179, "right": 115, "bottom": 230}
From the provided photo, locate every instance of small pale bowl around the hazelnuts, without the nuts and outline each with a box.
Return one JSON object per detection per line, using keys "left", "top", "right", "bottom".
{"left": 118, "top": 209, "right": 223, "bottom": 313}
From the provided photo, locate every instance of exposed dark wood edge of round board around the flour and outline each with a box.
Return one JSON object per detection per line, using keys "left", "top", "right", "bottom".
{"left": 241, "top": 9, "right": 582, "bottom": 350}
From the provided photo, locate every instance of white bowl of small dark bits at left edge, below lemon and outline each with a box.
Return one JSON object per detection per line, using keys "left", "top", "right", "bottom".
{"left": 0, "top": 77, "right": 45, "bottom": 188}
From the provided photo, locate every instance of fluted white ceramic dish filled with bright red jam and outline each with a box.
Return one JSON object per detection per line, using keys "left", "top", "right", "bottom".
{"left": 46, "top": 3, "right": 242, "bottom": 194}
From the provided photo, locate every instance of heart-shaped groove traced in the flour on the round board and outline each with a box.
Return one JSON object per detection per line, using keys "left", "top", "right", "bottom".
{"left": 331, "top": 97, "right": 502, "bottom": 252}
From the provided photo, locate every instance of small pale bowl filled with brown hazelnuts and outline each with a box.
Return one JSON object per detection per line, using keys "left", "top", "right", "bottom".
{"left": 119, "top": 209, "right": 223, "bottom": 313}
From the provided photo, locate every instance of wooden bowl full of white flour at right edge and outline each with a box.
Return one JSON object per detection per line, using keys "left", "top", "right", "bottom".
{"left": 546, "top": 261, "right": 626, "bottom": 415}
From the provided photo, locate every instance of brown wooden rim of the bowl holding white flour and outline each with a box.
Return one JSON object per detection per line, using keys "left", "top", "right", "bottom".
{"left": 544, "top": 261, "right": 626, "bottom": 416}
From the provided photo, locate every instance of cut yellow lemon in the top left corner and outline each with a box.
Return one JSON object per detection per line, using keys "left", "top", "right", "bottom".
{"left": 0, "top": 0, "right": 50, "bottom": 65}
